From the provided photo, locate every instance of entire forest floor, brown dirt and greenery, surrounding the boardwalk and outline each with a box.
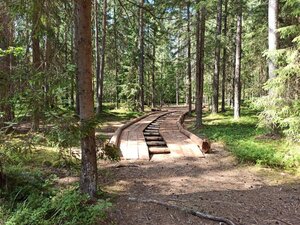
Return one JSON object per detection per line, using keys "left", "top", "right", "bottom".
{"left": 0, "top": 109, "right": 300, "bottom": 225}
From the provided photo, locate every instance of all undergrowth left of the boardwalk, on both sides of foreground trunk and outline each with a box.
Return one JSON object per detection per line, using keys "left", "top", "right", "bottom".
{"left": 0, "top": 104, "right": 140, "bottom": 225}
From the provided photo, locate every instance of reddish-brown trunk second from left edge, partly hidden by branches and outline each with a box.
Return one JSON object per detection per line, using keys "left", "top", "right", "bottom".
{"left": 31, "top": 0, "right": 42, "bottom": 131}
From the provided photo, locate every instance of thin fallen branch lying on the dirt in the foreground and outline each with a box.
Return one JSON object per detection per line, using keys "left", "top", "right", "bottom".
{"left": 128, "top": 198, "right": 235, "bottom": 225}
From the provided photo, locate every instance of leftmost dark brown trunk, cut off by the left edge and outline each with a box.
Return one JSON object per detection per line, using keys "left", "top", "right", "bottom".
{"left": 0, "top": 3, "right": 13, "bottom": 128}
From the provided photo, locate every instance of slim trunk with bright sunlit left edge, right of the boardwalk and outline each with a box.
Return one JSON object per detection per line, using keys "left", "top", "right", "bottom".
{"left": 234, "top": 0, "right": 243, "bottom": 119}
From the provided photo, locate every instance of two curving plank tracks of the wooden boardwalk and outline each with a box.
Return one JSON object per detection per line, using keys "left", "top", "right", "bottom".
{"left": 113, "top": 109, "right": 204, "bottom": 160}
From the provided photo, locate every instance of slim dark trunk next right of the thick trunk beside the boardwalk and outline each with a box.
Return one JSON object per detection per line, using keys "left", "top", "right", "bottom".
{"left": 212, "top": 0, "right": 222, "bottom": 113}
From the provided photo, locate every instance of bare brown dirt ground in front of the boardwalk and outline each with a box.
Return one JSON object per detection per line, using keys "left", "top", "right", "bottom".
{"left": 99, "top": 109, "right": 300, "bottom": 225}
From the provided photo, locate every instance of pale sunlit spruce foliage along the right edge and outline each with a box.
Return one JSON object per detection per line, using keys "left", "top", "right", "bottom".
{"left": 254, "top": 0, "right": 300, "bottom": 142}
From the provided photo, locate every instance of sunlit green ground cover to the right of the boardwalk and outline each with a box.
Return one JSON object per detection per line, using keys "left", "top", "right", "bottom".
{"left": 190, "top": 109, "right": 300, "bottom": 170}
